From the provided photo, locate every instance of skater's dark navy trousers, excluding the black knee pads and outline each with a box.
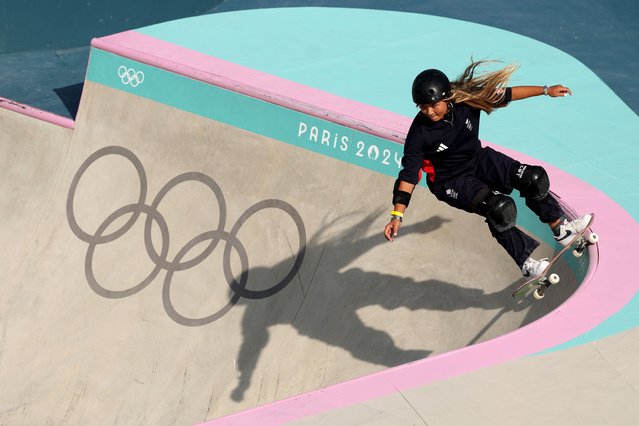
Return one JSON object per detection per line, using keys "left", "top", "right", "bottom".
{"left": 428, "top": 147, "right": 563, "bottom": 268}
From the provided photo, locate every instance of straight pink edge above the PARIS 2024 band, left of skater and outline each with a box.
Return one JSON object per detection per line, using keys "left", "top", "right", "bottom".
{"left": 91, "top": 31, "right": 406, "bottom": 142}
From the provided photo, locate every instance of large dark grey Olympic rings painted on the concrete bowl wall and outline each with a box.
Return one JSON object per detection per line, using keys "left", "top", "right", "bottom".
{"left": 66, "top": 146, "right": 306, "bottom": 326}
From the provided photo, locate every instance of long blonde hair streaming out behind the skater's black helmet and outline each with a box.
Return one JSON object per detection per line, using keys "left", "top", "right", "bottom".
{"left": 446, "top": 58, "right": 519, "bottom": 114}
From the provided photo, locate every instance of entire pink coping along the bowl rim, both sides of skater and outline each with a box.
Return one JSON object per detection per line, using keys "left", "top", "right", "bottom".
{"left": 92, "top": 31, "right": 639, "bottom": 426}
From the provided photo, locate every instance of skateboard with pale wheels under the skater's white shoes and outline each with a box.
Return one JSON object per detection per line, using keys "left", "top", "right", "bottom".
{"left": 513, "top": 213, "right": 599, "bottom": 300}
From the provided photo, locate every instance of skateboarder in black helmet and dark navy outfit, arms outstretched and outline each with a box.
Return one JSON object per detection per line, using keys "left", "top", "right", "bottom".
{"left": 384, "top": 61, "right": 590, "bottom": 277}
